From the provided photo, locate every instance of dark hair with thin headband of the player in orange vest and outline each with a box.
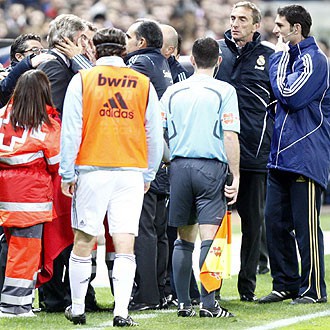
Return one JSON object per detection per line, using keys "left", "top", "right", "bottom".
{"left": 93, "top": 28, "right": 126, "bottom": 59}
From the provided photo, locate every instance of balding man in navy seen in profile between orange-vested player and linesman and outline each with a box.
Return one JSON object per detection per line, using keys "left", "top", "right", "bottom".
{"left": 124, "top": 20, "right": 173, "bottom": 311}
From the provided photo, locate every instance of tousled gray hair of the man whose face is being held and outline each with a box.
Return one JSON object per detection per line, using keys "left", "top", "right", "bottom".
{"left": 47, "top": 14, "right": 87, "bottom": 49}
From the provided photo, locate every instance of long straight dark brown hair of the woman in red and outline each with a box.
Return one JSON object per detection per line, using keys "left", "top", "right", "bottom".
{"left": 10, "top": 69, "right": 54, "bottom": 129}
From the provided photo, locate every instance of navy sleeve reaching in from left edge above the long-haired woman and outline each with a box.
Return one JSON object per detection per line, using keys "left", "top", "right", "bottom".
{"left": 0, "top": 56, "right": 32, "bottom": 107}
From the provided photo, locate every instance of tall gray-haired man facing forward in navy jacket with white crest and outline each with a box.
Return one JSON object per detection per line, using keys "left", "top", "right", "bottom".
{"left": 216, "top": 1, "right": 274, "bottom": 302}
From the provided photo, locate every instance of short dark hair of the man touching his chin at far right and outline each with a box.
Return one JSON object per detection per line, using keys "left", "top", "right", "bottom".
{"left": 277, "top": 5, "right": 312, "bottom": 38}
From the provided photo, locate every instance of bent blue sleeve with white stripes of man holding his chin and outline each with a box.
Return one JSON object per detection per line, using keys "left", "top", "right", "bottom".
{"left": 269, "top": 52, "right": 327, "bottom": 112}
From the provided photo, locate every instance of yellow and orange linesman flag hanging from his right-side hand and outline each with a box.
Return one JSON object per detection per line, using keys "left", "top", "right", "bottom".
{"left": 200, "top": 174, "right": 232, "bottom": 293}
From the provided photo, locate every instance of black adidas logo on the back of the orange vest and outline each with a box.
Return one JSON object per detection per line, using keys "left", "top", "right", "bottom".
{"left": 99, "top": 93, "right": 134, "bottom": 119}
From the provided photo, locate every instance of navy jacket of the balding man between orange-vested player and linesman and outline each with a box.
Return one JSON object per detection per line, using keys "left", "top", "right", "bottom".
{"left": 124, "top": 47, "right": 173, "bottom": 194}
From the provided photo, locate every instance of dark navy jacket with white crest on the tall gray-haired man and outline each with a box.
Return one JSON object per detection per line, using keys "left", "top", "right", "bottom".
{"left": 216, "top": 30, "right": 274, "bottom": 172}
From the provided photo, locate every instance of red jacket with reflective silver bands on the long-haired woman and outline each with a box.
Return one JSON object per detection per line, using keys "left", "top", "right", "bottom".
{"left": 0, "top": 104, "right": 60, "bottom": 227}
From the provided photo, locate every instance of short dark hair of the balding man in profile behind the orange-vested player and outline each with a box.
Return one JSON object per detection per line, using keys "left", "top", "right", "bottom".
{"left": 135, "top": 20, "right": 163, "bottom": 48}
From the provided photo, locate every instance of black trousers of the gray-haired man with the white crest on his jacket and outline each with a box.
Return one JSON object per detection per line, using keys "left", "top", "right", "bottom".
{"left": 237, "top": 171, "right": 267, "bottom": 296}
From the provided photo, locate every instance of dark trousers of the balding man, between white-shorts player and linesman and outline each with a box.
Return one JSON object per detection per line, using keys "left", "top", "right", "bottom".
{"left": 133, "top": 190, "right": 168, "bottom": 304}
